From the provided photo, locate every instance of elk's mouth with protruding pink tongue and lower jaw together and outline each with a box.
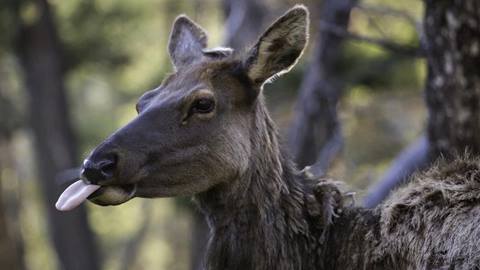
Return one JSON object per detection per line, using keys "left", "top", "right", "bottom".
{"left": 55, "top": 180, "right": 136, "bottom": 211}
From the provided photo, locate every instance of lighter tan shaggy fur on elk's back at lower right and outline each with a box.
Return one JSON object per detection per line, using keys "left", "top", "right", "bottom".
{"left": 377, "top": 157, "right": 480, "bottom": 269}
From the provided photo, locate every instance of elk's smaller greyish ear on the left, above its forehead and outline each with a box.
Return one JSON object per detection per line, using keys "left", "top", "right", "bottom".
{"left": 168, "top": 15, "right": 207, "bottom": 69}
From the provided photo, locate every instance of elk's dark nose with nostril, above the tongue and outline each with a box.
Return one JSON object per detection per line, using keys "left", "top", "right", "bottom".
{"left": 81, "top": 156, "right": 116, "bottom": 184}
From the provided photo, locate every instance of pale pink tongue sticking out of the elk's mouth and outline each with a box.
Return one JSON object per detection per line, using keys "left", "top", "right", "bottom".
{"left": 55, "top": 180, "right": 100, "bottom": 211}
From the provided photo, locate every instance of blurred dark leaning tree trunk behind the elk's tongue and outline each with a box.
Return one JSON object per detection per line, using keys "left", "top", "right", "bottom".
{"left": 16, "top": 0, "right": 99, "bottom": 270}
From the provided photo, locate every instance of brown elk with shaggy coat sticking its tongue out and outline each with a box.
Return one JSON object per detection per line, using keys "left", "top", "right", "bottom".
{"left": 57, "top": 6, "right": 480, "bottom": 270}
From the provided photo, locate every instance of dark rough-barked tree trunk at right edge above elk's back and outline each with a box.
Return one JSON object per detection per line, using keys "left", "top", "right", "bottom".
{"left": 424, "top": 0, "right": 480, "bottom": 157}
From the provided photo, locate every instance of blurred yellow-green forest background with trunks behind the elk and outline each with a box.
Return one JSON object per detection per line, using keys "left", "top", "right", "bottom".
{"left": 0, "top": 0, "right": 478, "bottom": 270}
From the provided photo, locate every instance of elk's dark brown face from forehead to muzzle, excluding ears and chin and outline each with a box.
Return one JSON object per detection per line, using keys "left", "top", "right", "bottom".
{"left": 84, "top": 64, "right": 251, "bottom": 205}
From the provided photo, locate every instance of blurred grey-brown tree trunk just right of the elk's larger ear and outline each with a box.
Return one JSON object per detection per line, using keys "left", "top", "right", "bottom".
{"left": 289, "top": 0, "right": 357, "bottom": 174}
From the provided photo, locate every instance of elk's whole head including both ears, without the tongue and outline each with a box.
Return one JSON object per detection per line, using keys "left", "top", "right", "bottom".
{"left": 82, "top": 5, "right": 308, "bottom": 205}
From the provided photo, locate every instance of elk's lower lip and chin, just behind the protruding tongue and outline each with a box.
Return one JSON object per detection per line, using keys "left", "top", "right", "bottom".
{"left": 88, "top": 184, "right": 136, "bottom": 206}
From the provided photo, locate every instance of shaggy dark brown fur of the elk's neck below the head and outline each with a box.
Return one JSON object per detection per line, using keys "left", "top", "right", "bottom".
{"left": 197, "top": 101, "right": 339, "bottom": 270}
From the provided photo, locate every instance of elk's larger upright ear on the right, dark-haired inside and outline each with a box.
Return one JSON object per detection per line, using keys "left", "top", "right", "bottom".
{"left": 244, "top": 5, "right": 309, "bottom": 86}
